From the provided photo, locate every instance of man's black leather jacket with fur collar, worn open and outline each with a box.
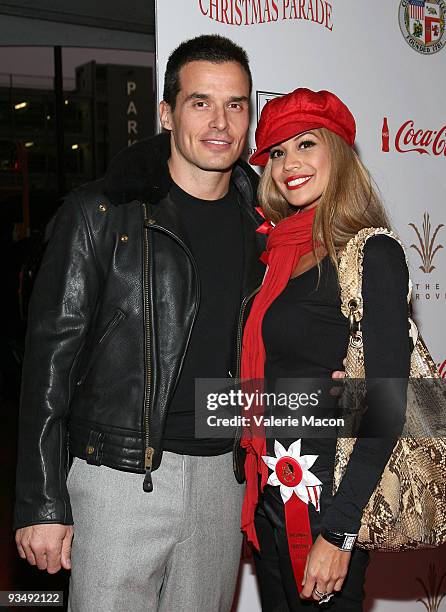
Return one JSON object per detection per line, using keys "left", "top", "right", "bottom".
{"left": 15, "top": 134, "right": 264, "bottom": 528}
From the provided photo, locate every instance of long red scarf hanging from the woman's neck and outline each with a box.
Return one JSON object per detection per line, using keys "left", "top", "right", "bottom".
{"left": 241, "top": 207, "right": 316, "bottom": 549}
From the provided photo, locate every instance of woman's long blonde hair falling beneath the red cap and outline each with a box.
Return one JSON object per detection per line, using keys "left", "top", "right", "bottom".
{"left": 258, "top": 128, "right": 391, "bottom": 268}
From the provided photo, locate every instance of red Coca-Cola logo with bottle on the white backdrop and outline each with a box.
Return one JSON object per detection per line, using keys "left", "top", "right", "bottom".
{"left": 382, "top": 117, "right": 446, "bottom": 157}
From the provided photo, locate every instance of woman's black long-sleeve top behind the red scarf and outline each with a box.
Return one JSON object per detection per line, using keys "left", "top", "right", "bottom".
{"left": 263, "top": 235, "right": 410, "bottom": 533}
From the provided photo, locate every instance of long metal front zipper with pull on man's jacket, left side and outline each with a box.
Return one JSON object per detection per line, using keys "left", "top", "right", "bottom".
{"left": 143, "top": 202, "right": 155, "bottom": 493}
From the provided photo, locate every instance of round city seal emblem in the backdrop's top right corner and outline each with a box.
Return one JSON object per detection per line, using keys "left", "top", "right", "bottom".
{"left": 399, "top": 0, "right": 446, "bottom": 55}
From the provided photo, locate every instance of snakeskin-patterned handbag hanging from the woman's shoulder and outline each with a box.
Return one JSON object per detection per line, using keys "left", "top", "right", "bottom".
{"left": 333, "top": 228, "right": 446, "bottom": 551}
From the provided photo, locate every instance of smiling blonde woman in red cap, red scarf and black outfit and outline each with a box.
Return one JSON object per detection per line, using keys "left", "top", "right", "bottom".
{"left": 242, "top": 89, "right": 410, "bottom": 612}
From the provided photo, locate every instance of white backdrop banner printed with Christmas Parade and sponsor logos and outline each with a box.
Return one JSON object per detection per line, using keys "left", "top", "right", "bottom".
{"left": 156, "top": 0, "right": 446, "bottom": 612}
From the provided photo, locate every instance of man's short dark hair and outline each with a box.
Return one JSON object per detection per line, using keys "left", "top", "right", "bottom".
{"left": 163, "top": 34, "right": 252, "bottom": 110}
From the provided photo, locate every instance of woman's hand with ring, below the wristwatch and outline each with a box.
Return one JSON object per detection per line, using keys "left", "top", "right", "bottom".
{"left": 300, "top": 535, "right": 351, "bottom": 601}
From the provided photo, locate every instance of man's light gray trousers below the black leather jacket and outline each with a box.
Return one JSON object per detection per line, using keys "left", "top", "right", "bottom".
{"left": 67, "top": 452, "right": 243, "bottom": 612}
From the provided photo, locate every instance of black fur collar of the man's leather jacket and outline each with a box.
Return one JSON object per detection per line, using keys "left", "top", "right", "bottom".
{"left": 105, "top": 133, "right": 261, "bottom": 222}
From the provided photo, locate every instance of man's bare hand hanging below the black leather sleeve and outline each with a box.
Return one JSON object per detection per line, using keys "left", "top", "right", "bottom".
{"left": 15, "top": 523, "right": 73, "bottom": 574}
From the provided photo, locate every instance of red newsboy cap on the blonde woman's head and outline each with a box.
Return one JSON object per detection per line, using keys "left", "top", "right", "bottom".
{"left": 249, "top": 87, "right": 356, "bottom": 166}
